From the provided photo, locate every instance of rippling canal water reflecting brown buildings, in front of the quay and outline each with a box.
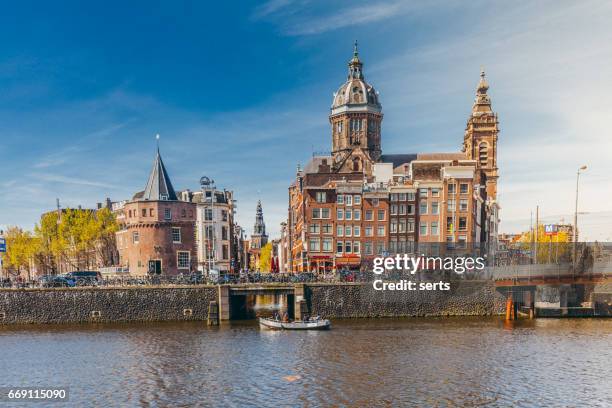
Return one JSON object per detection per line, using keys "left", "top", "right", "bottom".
{"left": 0, "top": 318, "right": 612, "bottom": 407}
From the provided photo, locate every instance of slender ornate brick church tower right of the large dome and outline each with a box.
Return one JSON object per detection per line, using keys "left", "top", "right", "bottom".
{"left": 462, "top": 69, "right": 499, "bottom": 200}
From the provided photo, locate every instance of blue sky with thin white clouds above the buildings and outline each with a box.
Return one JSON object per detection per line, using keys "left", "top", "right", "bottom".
{"left": 0, "top": 0, "right": 612, "bottom": 240}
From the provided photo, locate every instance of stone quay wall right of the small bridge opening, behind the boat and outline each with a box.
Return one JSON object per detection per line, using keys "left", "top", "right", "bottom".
{"left": 305, "top": 281, "right": 505, "bottom": 318}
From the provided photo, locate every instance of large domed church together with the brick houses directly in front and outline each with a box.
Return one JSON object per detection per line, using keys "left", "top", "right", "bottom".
{"left": 280, "top": 42, "right": 500, "bottom": 274}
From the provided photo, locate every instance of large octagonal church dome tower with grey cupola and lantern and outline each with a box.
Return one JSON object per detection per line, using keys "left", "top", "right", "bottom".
{"left": 329, "top": 41, "right": 383, "bottom": 174}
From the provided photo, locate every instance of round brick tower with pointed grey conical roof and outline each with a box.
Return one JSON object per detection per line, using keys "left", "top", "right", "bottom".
{"left": 115, "top": 149, "right": 197, "bottom": 276}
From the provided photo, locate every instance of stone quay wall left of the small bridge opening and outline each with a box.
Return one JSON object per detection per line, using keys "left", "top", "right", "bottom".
{"left": 0, "top": 286, "right": 218, "bottom": 324}
